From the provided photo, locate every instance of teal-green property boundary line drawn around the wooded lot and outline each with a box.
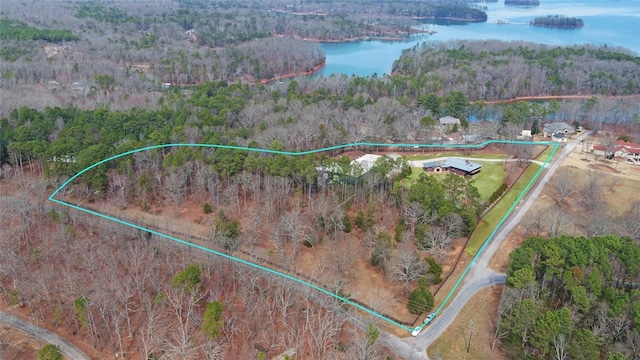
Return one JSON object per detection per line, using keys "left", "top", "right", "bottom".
{"left": 49, "top": 140, "right": 560, "bottom": 331}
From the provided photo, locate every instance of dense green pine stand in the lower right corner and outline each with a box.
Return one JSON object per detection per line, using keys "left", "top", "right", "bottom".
{"left": 496, "top": 235, "right": 640, "bottom": 359}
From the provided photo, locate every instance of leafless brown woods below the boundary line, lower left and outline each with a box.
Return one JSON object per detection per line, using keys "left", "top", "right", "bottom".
{"left": 0, "top": 177, "right": 392, "bottom": 359}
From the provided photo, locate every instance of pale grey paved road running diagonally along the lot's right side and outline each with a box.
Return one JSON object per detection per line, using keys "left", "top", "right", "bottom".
{"left": 383, "top": 132, "right": 589, "bottom": 359}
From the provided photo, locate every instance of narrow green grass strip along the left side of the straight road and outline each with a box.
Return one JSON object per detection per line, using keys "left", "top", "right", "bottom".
{"left": 465, "top": 163, "right": 540, "bottom": 256}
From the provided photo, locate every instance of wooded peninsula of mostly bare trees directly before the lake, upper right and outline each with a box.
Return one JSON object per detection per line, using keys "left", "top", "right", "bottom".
{"left": 393, "top": 40, "right": 640, "bottom": 101}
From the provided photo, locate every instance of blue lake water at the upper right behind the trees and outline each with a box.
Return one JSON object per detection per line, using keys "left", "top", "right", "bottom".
{"left": 315, "top": 0, "right": 640, "bottom": 76}
